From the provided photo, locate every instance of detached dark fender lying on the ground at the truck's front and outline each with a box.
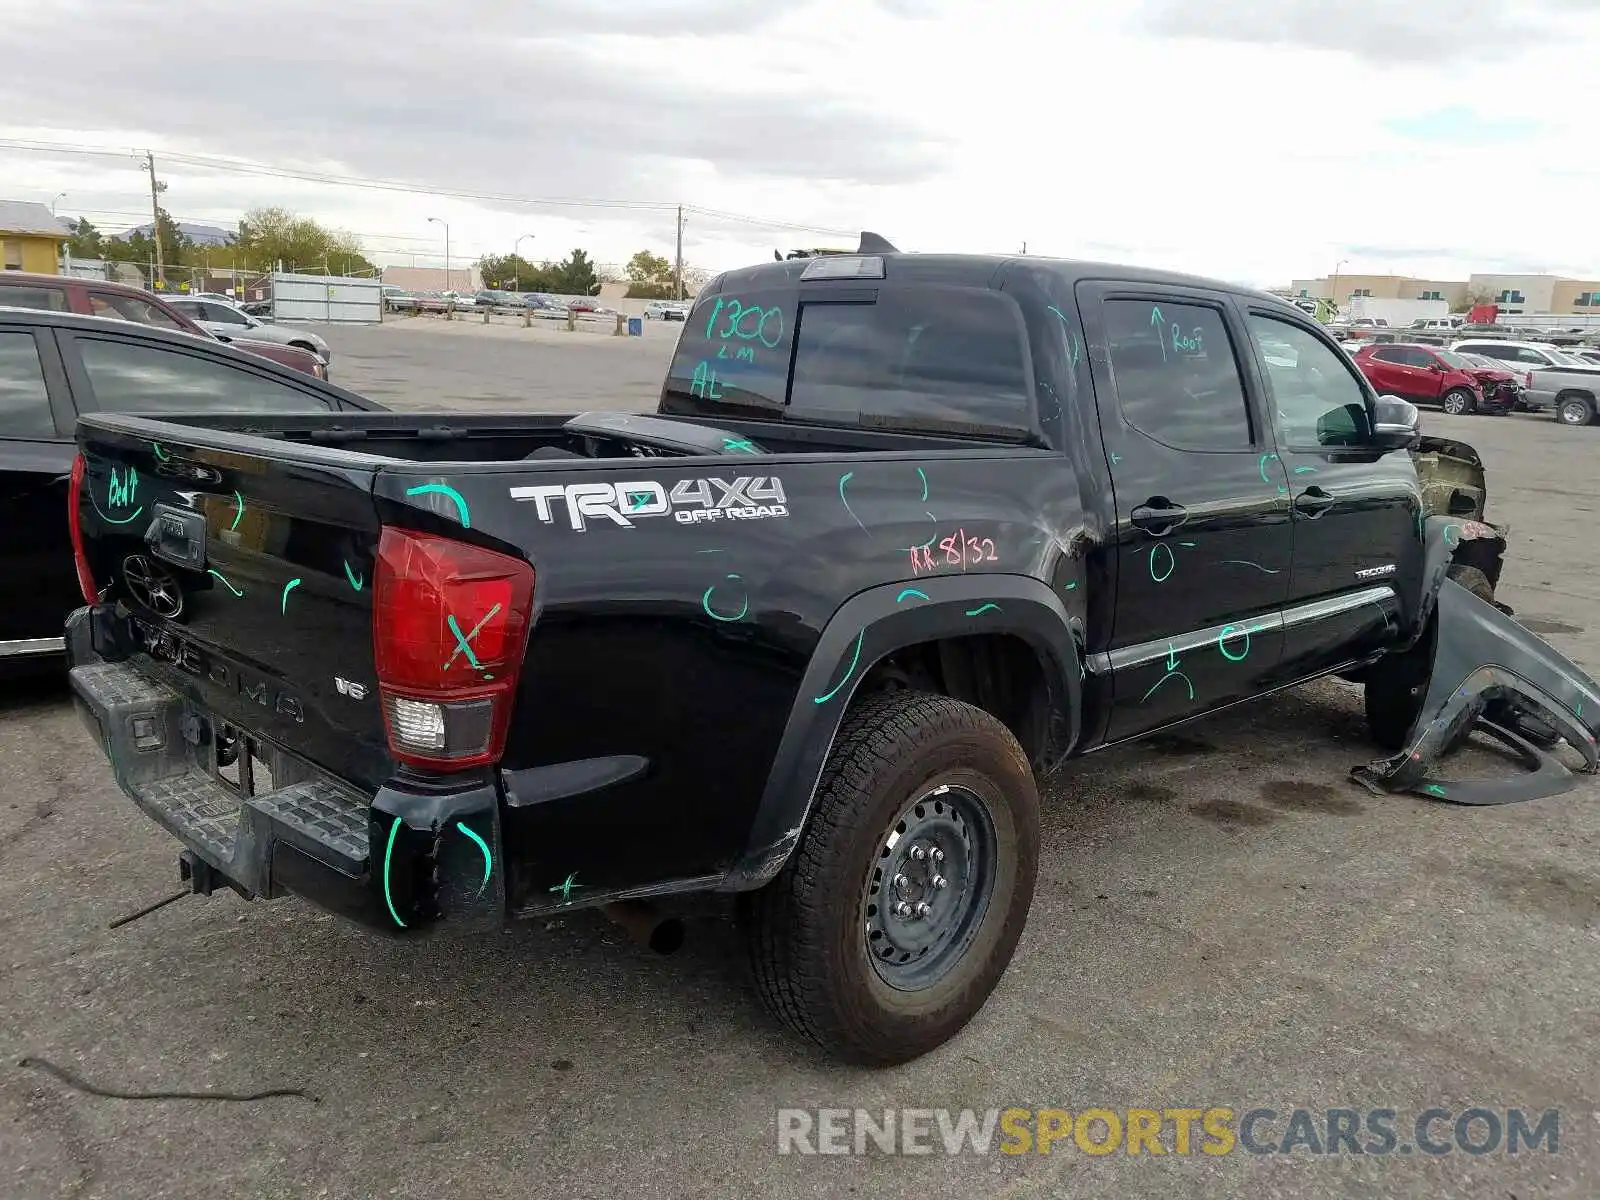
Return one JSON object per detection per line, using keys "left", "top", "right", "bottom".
{"left": 1352, "top": 579, "right": 1600, "bottom": 805}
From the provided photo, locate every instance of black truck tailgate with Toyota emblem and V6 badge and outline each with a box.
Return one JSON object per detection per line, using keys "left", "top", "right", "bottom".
{"left": 77, "top": 416, "right": 394, "bottom": 790}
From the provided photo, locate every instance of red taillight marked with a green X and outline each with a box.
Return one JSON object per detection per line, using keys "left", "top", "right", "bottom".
{"left": 373, "top": 528, "right": 534, "bottom": 770}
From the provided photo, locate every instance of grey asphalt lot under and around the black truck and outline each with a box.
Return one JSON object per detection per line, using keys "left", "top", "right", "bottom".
{"left": 0, "top": 322, "right": 1600, "bottom": 1200}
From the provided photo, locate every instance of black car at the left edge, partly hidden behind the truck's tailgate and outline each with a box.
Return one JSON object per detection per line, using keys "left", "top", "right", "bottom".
{"left": 0, "top": 307, "right": 382, "bottom": 674}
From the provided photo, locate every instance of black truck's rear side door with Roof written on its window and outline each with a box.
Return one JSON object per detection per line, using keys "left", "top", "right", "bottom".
{"left": 1078, "top": 283, "right": 1291, "bottom": 741}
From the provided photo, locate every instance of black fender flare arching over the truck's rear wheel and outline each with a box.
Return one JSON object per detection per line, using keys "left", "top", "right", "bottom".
{"left": 718, "top": 573, "right": 1083, "bottom": 891}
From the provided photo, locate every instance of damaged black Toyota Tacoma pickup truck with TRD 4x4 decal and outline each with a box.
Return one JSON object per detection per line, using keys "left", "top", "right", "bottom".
{"left": 67, "top": 235, "right": 1600, "bottom": 1062}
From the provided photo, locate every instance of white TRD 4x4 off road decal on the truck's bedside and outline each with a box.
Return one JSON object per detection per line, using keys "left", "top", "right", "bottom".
{"left": 510, "top": 475, "right": 789, "bottom": 533}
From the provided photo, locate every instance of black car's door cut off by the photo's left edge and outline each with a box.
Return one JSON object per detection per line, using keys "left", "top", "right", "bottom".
{"left": 0, "top": 324, "right": 83, "bottom": 652}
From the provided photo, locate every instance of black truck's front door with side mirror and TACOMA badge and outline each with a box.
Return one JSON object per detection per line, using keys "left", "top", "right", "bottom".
{"left": 1245, "top": 309, "right": 1422, "bottom": 682}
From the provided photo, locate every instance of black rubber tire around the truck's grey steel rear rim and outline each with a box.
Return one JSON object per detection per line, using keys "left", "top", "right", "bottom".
{"left": 742, "top": 691, "right": 1038, "bottom": 1066}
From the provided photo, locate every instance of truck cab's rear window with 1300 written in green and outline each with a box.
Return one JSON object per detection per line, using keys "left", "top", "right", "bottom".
{"left": 667, "top": 288, "right": 1034, "bottom": 437}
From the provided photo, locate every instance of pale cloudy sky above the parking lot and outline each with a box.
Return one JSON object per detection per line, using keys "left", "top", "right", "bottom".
{"left": 0, "top": 0, "right": 1600, "bottom": 285}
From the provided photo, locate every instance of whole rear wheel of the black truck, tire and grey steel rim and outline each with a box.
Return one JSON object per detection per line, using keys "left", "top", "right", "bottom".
{"left": 746, "top": 691, "right": 1038, "bottom": 1066}
